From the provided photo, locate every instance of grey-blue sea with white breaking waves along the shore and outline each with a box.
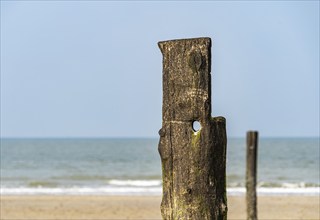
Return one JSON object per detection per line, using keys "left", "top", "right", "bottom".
{"left": 0, "top": 138, "right": 320, "bottom": 196}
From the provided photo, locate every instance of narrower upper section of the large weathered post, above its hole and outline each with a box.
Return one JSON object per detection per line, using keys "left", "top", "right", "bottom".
{"left": 158, "top": 37, "right": 211, "bottom": 121}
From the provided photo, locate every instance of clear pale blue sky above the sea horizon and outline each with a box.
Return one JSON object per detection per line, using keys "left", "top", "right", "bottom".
{"left": 1, "top": 1, "right": 319, "bottom": 137}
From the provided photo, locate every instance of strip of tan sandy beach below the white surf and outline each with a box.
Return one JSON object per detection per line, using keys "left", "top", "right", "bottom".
{"left": 1, "top": 196, "right": 320, "bottom": 220}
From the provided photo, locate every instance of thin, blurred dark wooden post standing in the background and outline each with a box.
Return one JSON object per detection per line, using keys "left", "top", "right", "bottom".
{"left": 246, "top": 131, "right": 258, "bottom": 220}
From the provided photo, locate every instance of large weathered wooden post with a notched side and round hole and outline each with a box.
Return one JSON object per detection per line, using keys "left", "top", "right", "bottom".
{"left": 158, "top": 38, "right": 227, "bottom": 220}
